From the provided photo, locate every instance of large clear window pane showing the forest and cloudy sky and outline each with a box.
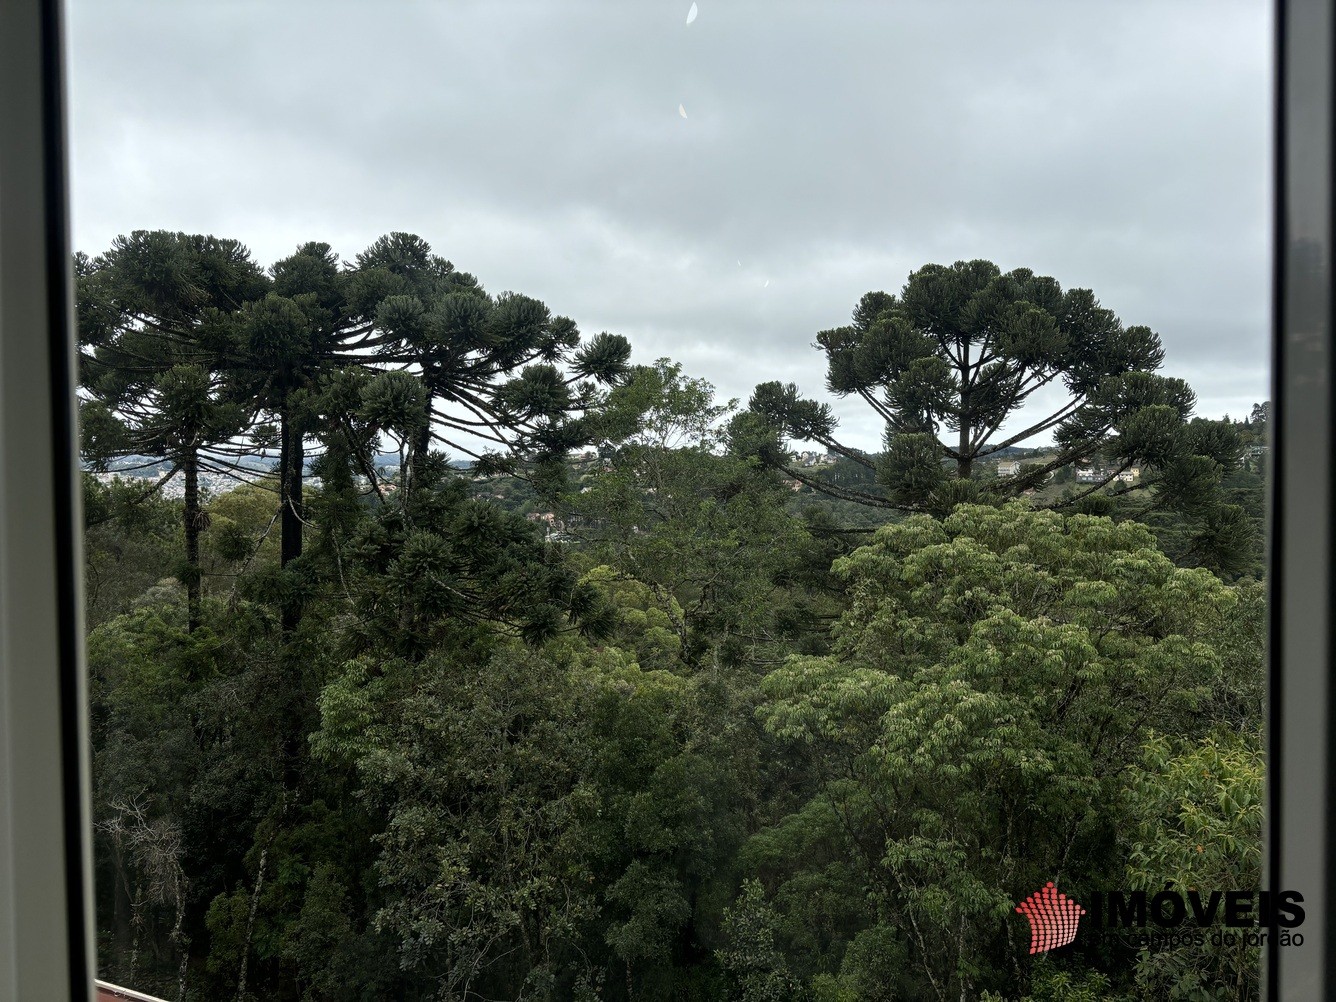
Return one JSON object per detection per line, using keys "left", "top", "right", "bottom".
{"left": 69, "top": 0, "right": 1271, "bottom": 1002}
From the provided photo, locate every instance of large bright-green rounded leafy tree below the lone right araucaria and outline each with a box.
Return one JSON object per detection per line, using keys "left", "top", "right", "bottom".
{"left": 745, "top": 505, "right": 1236, "bottom": 998}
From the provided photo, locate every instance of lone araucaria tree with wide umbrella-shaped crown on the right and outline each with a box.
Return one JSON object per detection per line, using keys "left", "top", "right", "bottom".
{"left": 751, "top": 261, "right": 1237, "bottom": 537}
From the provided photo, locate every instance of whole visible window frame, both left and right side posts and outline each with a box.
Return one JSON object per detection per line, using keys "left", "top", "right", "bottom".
{"left": 0, "top": 0, "right": 1319, "bottom": 1001}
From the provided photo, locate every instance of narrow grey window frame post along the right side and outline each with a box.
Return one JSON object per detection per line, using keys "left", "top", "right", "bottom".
{"left": 1263, "top": 0, "right": 1336, "bottom": 999}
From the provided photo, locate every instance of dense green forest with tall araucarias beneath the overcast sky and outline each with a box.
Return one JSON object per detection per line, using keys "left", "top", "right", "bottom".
{"left": 75, "top": 231, "right": 1269, "bottom": 1002}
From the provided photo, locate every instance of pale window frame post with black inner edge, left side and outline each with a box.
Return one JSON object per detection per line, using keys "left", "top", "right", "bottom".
{"left": 0, "top": 0, "right": 95, "bottom": 1002}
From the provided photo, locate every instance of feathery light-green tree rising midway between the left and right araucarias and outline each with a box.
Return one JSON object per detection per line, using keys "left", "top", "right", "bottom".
{"left": 562, "top": 358, "right": 830, "bottom": 663}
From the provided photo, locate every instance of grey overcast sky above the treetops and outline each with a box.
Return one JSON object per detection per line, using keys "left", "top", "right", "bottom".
{"left": 68, "top": 0, "right": 1272, "bottom": 449}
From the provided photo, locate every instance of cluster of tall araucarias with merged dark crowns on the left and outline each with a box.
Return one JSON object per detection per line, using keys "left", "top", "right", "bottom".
{"left": 76, "top": 231, "right": 631, "bottom": 627}
